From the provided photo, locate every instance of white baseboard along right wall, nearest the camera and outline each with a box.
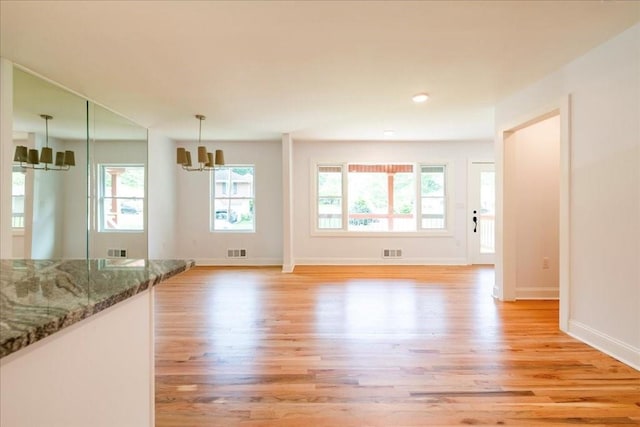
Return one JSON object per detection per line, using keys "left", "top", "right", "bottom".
{"left": 567, "top": 320, "right": 640, "bottom": 371}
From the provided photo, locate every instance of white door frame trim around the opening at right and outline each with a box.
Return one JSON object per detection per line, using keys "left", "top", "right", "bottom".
{"left": 494, "top": 95, "right": 571, "bottom": 331}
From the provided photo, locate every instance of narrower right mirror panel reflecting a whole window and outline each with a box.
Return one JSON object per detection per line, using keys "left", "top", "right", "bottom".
{"left": 89, "top": 103, "right": 147, "bottom": 258}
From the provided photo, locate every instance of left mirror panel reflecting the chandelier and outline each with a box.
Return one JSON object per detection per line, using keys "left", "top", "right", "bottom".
{"left": 12, "top": 67, "right": 88, "bottom": 259}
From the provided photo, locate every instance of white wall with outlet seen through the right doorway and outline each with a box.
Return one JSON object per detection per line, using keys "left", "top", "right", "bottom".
{"left": 505, "top": 115, "right": 560, "bottom": 299}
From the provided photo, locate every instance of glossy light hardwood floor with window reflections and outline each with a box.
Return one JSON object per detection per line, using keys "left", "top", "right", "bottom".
{"left": 155, "top": 266, "right": 640, "bottom": 427}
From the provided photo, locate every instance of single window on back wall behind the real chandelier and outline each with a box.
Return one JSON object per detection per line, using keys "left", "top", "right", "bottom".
{"left": 211, "top": 165, "right": 255, "bottom": 231}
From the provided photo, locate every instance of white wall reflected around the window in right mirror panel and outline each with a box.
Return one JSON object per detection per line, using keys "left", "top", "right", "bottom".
{"left": 89, "top": 141, "right": 147, "bottom": 258}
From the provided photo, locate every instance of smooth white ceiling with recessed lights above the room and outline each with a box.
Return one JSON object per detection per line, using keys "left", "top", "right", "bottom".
{"left": 0, "top": 0, "right": 640, "bottom": 140}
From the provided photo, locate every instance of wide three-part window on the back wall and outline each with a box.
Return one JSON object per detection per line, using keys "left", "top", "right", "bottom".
{"left": 316, "top": 163, "right": 448, "bottom": 232}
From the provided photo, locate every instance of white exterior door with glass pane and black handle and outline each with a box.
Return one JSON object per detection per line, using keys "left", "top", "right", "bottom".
{"left": 467, "top": 162, "right": 496, "bottom": 264}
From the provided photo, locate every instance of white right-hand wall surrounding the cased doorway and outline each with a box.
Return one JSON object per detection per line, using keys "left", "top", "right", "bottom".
{"left": 496, "top": 24, "right": 640, "bottom": 369}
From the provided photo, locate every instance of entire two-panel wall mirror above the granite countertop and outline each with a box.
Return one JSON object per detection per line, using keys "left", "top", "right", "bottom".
{"left": 11, "top": 67, "right": 147, "bottom": 259}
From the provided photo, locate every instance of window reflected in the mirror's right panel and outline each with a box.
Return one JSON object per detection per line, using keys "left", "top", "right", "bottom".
{"left": 99, "top": 164, "right": 144, "bottom": 231}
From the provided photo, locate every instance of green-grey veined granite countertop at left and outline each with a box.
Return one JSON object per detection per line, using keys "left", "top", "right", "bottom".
{"left": 0, "top": 259, "right": 194, "bottom": 358}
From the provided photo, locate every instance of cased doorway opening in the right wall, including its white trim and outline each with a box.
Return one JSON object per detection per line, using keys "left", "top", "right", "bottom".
{"left": 494, "top": 96, "right": 570, "bottom": 330}
